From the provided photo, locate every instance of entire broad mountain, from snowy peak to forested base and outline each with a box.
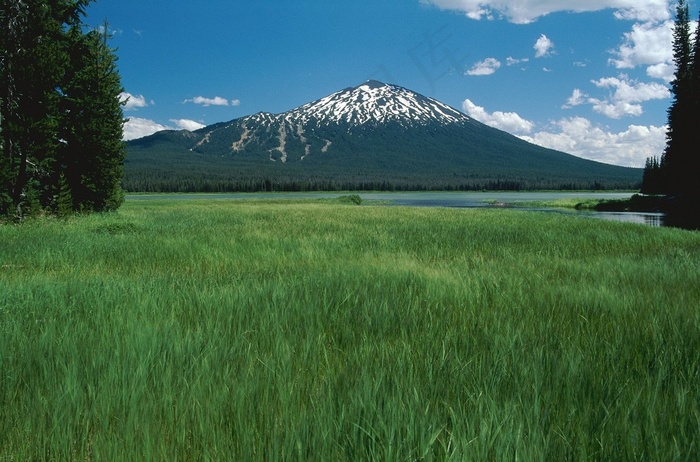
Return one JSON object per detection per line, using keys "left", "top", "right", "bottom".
{"left": 125, "top": 81, "right": 641, "bottom": 190}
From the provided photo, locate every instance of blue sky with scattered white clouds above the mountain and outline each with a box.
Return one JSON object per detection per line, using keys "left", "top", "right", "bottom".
{"left": 86, "top": 0, "right": 698, "bottom": 167}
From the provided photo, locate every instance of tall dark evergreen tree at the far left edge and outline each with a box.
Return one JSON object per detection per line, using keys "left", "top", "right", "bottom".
{"left": 0, "top": 0, "right": 65, "bottom": 215}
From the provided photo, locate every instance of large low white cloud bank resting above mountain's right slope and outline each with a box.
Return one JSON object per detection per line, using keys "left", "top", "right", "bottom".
{"left": 521, "top": 117, "right": 666, "bottom": 167}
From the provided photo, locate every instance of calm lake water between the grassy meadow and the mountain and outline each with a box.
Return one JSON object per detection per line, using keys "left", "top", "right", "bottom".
{"left": 126, "top": 191, "right": 664, "bottom": 226}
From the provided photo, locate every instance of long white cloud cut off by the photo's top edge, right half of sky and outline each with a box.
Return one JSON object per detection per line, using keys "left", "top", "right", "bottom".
{"left": 421, "top": 0, "right": 671, "bottom": 24}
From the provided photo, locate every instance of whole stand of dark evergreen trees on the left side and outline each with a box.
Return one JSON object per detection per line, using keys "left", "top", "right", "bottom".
{"left": 0, "top": 0, "right": 125, "bottom": 220}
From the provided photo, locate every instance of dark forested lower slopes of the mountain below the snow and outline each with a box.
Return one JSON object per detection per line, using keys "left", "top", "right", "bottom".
{"left": 124, "top": 118, "right": 642, "bottom": 192}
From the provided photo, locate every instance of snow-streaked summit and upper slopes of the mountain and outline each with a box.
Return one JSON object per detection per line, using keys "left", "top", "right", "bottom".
{"left": 192, "top": 80, "right": 473, "bottom": 163}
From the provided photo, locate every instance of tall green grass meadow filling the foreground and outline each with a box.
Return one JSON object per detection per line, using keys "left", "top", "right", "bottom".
{"left": 0, "top": 199, "right": 700, "bottom": 462}
